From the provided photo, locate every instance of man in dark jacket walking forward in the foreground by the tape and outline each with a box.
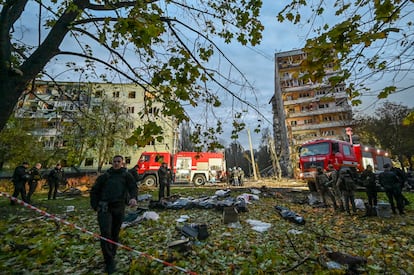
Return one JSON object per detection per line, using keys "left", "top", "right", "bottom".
{"left": 90, "top": 155, "right": 138, "bottom": 274}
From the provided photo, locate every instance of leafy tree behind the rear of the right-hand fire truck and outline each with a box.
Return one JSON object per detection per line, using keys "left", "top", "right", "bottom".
{"left": 356, "top": 101, "right": 414, "bottom": 168}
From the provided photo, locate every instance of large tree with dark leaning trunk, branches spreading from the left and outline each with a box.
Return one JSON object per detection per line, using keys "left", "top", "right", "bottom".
{"left": 0, "top": 0, "right": 263, "bottom": 148}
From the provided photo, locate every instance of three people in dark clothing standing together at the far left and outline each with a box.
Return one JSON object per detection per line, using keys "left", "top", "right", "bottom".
{"left": 10, "top": 161, "right": 65, "bottom": 205}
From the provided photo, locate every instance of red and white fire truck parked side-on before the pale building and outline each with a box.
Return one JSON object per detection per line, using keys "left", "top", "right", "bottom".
{"left": 137, "top": 152, "right": 226, "bottom": 186}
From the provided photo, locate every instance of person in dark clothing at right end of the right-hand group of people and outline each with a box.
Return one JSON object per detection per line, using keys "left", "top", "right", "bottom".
{"left": 379, "top": 163, "right": 405, "bottom": 215}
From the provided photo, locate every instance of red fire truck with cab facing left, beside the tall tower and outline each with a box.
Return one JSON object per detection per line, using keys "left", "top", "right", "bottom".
{"left": 299, "top": 139, "right": 391, "bottom": 181}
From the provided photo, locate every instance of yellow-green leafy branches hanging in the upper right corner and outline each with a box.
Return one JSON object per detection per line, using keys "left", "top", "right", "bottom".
{"left": 278, "top": 0, "right": 414, "bottom": 105}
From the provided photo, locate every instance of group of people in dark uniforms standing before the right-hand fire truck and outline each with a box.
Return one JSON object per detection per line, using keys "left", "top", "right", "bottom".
{"left": 315, "top": 163, "right": 409, "bottom": 215}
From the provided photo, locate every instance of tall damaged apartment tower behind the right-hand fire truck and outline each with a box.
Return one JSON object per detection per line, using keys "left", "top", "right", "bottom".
{"left": 272, "top": 50, "right": 352, "bottom": 178}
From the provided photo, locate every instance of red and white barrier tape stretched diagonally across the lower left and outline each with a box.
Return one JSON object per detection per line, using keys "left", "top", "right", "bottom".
{"left": 0, "top": 191, "right": 197, "bottom": 275}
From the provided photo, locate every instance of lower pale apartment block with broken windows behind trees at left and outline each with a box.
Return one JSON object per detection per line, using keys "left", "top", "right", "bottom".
{"left": 15, "top": 81, "right": 177, "bottom": 169}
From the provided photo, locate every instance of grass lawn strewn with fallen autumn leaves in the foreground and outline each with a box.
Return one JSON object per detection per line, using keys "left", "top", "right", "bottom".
{"left": 0, "top": 181, "right": 414, "bottom": 274}
